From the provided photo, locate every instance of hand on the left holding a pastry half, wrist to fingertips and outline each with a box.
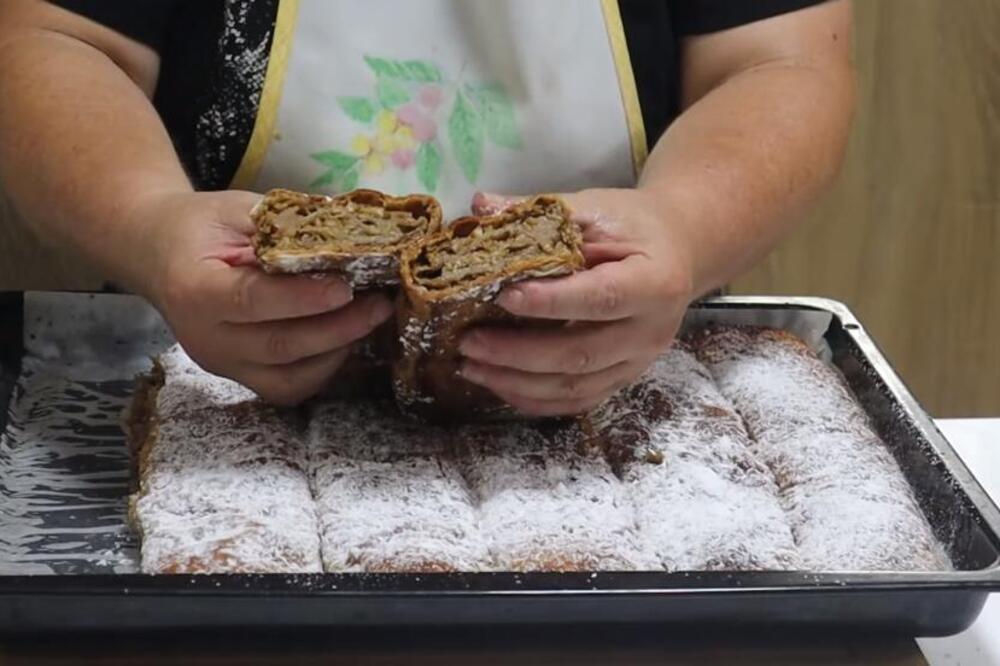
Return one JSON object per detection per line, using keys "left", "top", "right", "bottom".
{"left": 128, "top": 191, "right": 392, "bottom": 405}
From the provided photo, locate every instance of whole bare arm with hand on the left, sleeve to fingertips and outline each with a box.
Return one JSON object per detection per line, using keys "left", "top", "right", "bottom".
{"left": 0, "top": 0, "right": 391, "bottom": 403}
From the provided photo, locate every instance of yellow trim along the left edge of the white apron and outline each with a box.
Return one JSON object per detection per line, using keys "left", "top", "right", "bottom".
{"left": 230, "top": 0, "right": 299, "bottom": 190}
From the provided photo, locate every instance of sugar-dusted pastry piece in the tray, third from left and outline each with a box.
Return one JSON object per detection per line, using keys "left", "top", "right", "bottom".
{"left": 455, "top": 424, "right": 658, "bottom": 571}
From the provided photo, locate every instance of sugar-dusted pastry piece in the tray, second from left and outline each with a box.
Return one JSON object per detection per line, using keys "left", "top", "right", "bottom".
{"left": 309, "top": 402, "right": 492, "bottom": 572}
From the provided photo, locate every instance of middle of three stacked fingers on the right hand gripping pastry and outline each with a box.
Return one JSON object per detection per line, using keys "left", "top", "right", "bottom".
{"left": 459, "top": 320, "right": 655, "bottom": 375}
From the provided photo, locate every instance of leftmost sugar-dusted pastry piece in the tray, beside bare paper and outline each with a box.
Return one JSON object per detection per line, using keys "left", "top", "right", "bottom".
{"left": 133, "top": 347, "right": 322, "bottom": 573}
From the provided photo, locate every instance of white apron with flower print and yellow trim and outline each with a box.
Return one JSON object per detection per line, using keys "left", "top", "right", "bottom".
{"left": 233, "top": 0, "right": 646, "bottom": 219}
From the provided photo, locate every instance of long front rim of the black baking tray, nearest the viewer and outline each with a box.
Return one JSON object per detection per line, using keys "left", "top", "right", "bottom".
{"left": 0, "top": 567, "right": 1000, "bottom": 598}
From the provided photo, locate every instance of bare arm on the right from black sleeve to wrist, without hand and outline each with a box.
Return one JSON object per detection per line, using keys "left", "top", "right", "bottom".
{"left": 640, "top": 0, "right": 854, "bottom": 293}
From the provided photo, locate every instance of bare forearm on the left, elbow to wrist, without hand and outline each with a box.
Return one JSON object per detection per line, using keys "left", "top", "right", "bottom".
{"left": 0, "top": 28, "right": 190, "bottom": 293}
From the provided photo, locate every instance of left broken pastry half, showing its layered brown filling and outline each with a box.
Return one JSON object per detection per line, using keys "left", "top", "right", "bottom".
{"left": 250, "top": 190, "right": 441, "bottom": 289}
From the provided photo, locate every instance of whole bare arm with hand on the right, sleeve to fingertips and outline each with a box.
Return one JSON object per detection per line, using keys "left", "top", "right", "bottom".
{"left": 461, "top": 0, "right": 853, "bottom": 415}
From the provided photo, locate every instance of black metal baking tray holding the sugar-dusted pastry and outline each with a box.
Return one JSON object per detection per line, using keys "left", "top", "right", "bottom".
{"left": 0, "top": 293, "right": 1000, "bottom": 636}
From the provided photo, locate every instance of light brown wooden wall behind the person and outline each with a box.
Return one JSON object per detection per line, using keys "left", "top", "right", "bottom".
{"left": 0, "top": 0, "right": 1000, "bottom": 416}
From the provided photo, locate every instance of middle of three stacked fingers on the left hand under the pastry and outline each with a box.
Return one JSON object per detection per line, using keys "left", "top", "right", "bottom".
{"left": 221, "top": 294, "right": 393, "bottom": 365}
